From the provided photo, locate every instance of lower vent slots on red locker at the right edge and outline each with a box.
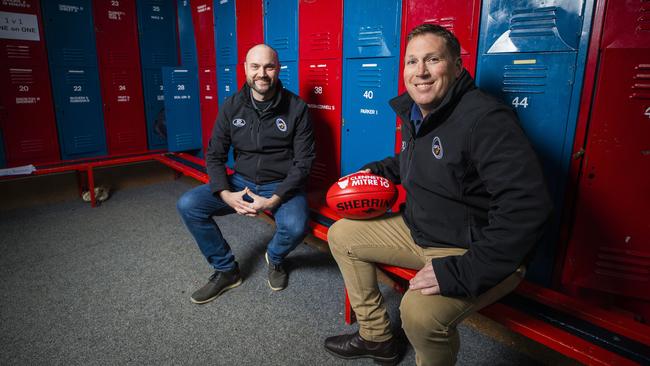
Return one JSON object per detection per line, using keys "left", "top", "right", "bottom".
{"left": 594, "top": 247, "right": 650, "bottom": 282}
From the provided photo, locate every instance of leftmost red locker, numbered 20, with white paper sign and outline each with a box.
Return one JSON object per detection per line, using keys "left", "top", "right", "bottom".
{"left": 0, "top": 0, "right": 60, "bottom": 167}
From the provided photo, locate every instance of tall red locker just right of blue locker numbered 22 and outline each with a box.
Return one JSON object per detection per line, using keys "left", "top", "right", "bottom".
{"left": 93, "top": 0, "right": 147, "bottom": 155}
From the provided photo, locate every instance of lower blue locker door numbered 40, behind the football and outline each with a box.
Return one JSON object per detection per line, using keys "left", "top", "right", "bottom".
{"left": 341, "top": 57, "right": 398, "bottom": 175}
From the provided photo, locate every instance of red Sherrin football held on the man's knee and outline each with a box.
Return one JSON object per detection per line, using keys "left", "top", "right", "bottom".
{"left": 326, "top": 173, "right": 397, "bottom": 219}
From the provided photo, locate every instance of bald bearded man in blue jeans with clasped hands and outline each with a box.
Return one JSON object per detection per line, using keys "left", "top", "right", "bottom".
{"left": 177, "top": 44, "right": 315, "bottom": 304}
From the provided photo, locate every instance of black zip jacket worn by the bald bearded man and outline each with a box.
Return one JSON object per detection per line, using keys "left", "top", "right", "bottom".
{"left": 206, "top": 80, "right": 315, "bottom": 199}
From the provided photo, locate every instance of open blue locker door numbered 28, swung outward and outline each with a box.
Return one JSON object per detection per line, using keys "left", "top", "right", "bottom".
{"left": 162, "top": 67, "right": 201, "bottom": 151}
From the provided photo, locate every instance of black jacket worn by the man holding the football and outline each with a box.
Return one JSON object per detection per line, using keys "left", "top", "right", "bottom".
{"left": 364, "top": 71, "right": 552, "bottom": 297}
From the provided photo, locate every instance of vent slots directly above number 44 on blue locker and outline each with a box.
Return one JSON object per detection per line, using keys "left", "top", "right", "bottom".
{"left": 502, "top": 65, "right": 548, "bottom": 94}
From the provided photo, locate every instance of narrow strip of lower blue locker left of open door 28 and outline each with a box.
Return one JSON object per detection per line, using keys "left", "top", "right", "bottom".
{"left": 142, "top": 67, "right": 167, "bottom": 150}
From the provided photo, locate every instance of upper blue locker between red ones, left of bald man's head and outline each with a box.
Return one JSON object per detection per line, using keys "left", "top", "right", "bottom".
{"left": 214, "top": 0, "right": 237, "bottom": 64}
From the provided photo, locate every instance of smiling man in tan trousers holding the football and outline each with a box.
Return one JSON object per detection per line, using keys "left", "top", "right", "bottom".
{"left": 325, "top": 24, "right": 551, "bottom": 366}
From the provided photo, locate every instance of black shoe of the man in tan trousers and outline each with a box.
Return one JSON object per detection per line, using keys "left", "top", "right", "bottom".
{"left": 325, "top": 332, "right": 399, "bottom": 365}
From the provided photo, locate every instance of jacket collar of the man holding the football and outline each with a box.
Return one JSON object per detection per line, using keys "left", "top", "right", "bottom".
{"left": 389, "top": 69, "right": 476, "bottom": 136}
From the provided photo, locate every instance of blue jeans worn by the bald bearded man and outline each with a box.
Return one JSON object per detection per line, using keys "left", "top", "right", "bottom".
{"left": 176, "top": 174, "right": 309, "bottom": 272}
